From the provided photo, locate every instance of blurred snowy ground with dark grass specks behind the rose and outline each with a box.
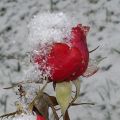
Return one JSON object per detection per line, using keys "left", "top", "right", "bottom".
{"left": 0, "top": 0, "right": 120, "bottom": 120}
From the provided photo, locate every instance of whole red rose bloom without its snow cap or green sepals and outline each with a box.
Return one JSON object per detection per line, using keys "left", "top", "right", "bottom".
{"left": 33, "top": 25, "right": 89, "bottom": 82}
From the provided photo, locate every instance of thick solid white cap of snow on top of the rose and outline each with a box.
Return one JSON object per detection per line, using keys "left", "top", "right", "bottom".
{"left": 28, "top": 12, "right": 72, "bottom": 46}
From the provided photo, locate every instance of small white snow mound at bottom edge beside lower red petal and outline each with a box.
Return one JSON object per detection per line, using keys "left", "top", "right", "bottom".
{"left": 13, "top": 114, "right": 36, "bottom": 120}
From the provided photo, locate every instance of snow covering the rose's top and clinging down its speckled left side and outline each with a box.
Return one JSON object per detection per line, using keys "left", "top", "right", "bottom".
{"left": 27, "top": 12, "right": 73, "bottom": 82}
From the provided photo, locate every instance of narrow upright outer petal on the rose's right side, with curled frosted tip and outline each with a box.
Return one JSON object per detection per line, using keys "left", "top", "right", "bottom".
{"left": 71, "top": 25, "right": 89, "bottom": 79}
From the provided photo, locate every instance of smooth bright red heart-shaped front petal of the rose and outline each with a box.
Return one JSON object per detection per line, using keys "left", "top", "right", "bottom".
{"left": 48, "top": 43, "right": 81, "bottom": 82}
